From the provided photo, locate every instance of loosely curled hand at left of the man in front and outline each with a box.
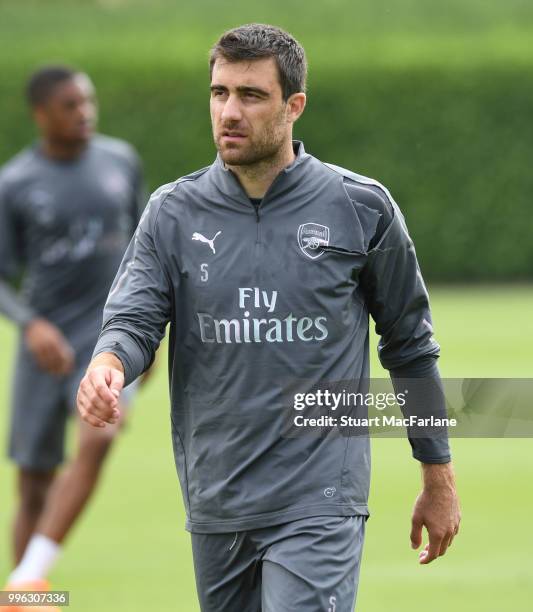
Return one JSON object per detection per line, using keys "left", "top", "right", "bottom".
{"left": 77, "top": 353, "right": 124, "bottom": 427}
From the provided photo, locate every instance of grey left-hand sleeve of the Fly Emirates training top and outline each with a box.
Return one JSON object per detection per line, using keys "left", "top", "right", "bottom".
{"left": 94, "top": 192, "right": 171, "bottom": 384}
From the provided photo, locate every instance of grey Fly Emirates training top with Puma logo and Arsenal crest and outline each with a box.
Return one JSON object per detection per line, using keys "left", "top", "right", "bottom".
{"left": 94, "top": 142, "right": 449, "bottom": 533}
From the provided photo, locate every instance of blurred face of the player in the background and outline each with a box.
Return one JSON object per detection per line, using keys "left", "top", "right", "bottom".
{"left": 34, "top": 74, "right": 98, "bottom": 144}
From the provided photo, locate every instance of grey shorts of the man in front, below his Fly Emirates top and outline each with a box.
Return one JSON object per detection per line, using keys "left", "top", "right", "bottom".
{"left": 191, "top": 516, "right": 367, "bottom": 612}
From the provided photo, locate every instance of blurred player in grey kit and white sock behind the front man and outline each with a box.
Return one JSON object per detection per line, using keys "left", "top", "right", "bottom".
{"left": 0, "top": 66, "right": 144, "bottom": 610}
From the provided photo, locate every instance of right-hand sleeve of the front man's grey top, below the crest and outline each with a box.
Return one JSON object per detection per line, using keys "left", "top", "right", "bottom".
{"left": 361, "top": 194, "right": 450, "bottom": 463}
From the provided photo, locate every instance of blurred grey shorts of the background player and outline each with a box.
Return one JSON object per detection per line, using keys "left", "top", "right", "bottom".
{"left": 9, "top": 341, "right": 135, "bottom": 472}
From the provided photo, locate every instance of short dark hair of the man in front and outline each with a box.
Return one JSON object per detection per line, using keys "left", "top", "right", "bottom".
{"left": 209, "top": 23, "right": 307, "bottom": 100}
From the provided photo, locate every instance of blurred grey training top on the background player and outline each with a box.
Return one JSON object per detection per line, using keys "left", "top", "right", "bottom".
{"left": 0, "top": 135, "right": 145, "bottom": 352}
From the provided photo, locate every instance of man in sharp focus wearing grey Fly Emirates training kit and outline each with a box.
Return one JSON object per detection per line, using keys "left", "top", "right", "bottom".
{"left": 78, "top": 24, "right": 459, "bottom": 612}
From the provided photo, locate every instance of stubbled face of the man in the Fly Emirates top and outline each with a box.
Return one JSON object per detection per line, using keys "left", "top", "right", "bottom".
{"left": 210, "top": 58, "right": 292, "bottom": 166}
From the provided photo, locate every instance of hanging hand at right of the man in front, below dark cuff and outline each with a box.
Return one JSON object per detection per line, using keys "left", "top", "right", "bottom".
{"left": 411, "top": 463, "right": 461, "bottom": 564}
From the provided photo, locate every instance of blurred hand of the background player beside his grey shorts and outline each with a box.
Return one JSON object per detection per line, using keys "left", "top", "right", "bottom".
{"left": 24, "top": 318, "right": 74, "bottom": 376}
